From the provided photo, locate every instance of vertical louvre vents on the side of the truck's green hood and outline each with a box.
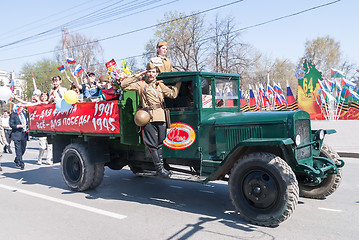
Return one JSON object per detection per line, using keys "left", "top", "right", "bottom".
{"left": 224, "top": 127, "right": 262, "bottom": 150}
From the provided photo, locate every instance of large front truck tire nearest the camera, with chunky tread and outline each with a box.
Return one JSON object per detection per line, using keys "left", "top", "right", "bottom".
{"left": 228, "top": 152, "right": 299, "bottom": 226}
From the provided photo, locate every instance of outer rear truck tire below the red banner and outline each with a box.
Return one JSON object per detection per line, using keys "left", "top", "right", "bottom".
{"left": 61, "top": 143, "right": 95, "bottom": 191}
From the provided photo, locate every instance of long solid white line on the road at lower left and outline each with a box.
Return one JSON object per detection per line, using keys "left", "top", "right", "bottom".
{"left": 0, "top": 184, "right": 127, "bottom": 219}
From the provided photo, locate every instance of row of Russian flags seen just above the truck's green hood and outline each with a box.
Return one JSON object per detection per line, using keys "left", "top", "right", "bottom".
{"left": 240, "top": 81, "right": 298, "bottom": 112}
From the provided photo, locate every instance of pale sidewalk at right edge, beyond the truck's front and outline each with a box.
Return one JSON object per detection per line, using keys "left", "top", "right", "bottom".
{"left": 312, "top": 120, "right": 359, "bottom": 158}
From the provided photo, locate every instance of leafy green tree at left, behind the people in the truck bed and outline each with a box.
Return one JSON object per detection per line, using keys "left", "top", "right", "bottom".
{"left": 21, "top": 59, "right": 70, "bottom": 100}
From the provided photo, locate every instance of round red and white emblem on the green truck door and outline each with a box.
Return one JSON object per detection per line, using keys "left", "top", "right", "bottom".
{"left": 163, "top": 123, "right": 196, "bottom": 150}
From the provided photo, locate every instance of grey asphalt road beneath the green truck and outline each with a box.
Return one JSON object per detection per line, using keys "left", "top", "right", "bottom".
{"left": 0, "top": 141, "right": 359, "bottom": 240}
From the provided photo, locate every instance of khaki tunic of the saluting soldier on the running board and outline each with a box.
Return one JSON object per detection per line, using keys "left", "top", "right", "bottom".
{"left": 121, "top": 77, "right": 181, "bottom": 122}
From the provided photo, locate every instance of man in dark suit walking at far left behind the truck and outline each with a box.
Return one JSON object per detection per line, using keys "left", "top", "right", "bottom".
{"left": 9, "top": 106, "right": 27, "bottom": 170}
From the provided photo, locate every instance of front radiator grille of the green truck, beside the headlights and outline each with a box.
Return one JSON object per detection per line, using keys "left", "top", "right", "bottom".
{"left": 295, "top": 119, "right": 312, "bottom": 160}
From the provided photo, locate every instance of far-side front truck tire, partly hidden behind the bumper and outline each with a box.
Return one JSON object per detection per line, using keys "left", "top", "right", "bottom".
{"left": 299, "top": 144, "right": 342, "bottom": 199}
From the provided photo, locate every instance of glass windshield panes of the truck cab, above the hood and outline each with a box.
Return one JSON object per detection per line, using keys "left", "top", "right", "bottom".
{"left": 202, "top": 77, "right": 238, "bottom": 108}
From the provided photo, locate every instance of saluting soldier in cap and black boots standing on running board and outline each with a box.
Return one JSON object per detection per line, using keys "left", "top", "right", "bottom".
{"left": 121, "top": 62, "right": 181, "bottom": 177}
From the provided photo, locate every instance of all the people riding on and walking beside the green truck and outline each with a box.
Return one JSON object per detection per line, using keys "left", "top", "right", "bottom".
{"left": 0, "top": 41, "right": 176, "bottom": 177}
